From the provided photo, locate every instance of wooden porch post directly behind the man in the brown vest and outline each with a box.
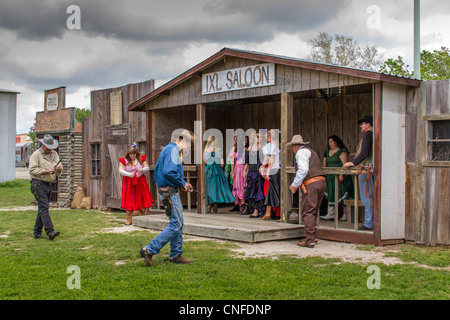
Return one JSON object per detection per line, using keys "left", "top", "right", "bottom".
{"left": 280, "top": 93, "right": 294, "bottom": 223}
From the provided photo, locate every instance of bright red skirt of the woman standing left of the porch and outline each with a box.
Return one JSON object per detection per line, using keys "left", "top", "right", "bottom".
{"left": 120, "top": 175, "right": 153, "bottom": 211}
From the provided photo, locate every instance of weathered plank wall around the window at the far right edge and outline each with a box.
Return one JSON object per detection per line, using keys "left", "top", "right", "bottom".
{"left": 405, "top": 80, "right": 450, "bottom": 245}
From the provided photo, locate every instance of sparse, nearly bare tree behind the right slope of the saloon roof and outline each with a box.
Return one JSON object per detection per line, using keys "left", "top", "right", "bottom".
{"left": 308, "top": 32, "right": 382, "bottom": 70}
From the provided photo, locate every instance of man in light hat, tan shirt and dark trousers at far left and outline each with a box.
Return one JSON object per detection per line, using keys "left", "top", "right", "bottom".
{"left": 30, "top": 134, "right": 62, "bottom": 240}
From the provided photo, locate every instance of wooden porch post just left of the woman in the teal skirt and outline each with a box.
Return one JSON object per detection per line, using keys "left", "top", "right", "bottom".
{"left": 194, "top": 103, "right": 206, "bottom": 214}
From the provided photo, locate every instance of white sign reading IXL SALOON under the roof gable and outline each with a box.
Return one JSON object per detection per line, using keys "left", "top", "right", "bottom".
{"left": 202, "top": 63, "right": 275, "bottom": 95}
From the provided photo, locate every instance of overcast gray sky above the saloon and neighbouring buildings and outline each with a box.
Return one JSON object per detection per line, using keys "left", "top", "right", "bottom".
{"left": 0, "top": 0, "right": 450, "bottom": 133}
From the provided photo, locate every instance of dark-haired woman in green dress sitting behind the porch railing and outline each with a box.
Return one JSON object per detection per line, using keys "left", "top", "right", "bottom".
{"left": 321, "top": 135, "right": 354, "bottom": 220}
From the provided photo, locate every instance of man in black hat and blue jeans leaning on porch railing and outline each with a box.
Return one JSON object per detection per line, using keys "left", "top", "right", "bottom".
{"left": 343, "top": 116, "right": 374, "bottom": 230}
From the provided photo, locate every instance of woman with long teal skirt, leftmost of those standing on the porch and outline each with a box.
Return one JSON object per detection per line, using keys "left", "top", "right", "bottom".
{"left": 205, "top": 136, "right": 234, "bottom": 213}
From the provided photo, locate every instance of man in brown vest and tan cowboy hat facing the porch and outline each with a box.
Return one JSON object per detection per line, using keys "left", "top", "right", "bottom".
{"left": 286, "top": 135, "right": 325, "bottom": 248}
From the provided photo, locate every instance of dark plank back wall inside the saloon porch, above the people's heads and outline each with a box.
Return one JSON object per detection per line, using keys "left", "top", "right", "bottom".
{"left": 151, "top": 93, "right": 372, "bottom": 168}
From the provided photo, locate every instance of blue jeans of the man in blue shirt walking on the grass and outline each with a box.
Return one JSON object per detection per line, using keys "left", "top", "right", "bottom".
{"left": 146, "top": 193, "right": 183, "bottom": 259}
